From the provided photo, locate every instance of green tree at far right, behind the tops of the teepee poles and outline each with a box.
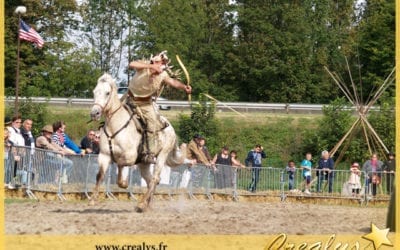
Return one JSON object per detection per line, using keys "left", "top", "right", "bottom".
{"left": 353, "top": 0, "right": 395, "bottom": 102}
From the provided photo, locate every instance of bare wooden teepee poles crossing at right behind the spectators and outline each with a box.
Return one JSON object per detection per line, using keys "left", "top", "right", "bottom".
{"left": 325, "top": 58, "right": 395, "bottom": 162}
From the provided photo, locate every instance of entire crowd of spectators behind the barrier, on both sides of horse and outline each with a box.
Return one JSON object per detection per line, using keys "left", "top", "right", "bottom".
{"left": 4, "top": 115, "right": 395, "bottom": 197}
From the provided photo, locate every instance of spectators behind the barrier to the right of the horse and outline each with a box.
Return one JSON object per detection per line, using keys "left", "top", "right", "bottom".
{"left": 187, "top": 134, "right": 395, "bottom": 197}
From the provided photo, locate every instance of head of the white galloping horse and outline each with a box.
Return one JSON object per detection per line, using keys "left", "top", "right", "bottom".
{"left": 90, "top": 73, "right": 119, "bottom": 121}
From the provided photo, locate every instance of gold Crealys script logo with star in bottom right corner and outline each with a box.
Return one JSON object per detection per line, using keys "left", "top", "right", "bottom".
{"left": 264, "top": 224, "right": 393, "bottom": 250}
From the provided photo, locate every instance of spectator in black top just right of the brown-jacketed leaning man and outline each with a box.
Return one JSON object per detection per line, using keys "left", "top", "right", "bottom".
{"left": 212, "top": 146, "right": 232, "bottom": 188}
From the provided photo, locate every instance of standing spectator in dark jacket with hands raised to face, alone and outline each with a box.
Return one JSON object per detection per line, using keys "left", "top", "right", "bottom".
{"left": 245, "top": 144, "right": 267, "bottom": 193}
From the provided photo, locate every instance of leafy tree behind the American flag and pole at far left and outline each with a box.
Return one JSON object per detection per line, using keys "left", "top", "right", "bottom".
{"left": 5, "top": 0, "right": 98, "bottom": 97}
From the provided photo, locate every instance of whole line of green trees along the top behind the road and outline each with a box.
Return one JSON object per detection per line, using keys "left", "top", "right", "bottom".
{"left": 4, "top": 0, "right": 395, "bottom": 104}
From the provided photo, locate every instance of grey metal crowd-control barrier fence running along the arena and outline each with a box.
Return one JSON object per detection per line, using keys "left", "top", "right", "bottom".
{"left": 4, "top": 147, "right": 395, "bottom": 203}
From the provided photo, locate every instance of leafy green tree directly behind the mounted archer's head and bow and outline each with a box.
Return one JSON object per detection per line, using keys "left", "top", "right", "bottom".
{"left": 132, "top": 0, "right": 238, "bottom": 99}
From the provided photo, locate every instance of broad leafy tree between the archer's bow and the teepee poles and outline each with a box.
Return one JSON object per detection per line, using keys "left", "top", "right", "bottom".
{"left": 236, "top": 0, "right": 353, "bottom": 103}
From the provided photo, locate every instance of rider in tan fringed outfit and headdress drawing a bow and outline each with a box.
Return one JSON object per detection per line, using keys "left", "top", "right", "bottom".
{"left": 125, "top": 51, "right": 192, "bottom": 163}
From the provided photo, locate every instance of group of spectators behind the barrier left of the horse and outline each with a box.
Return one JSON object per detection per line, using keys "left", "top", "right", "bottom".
{"left": 4, "top": 115, "right": 100, "bottom": 189}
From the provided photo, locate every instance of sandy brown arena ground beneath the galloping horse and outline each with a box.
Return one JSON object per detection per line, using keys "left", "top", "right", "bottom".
{"left": 5, "top": 197, "right": 387, "bottom": 235}
